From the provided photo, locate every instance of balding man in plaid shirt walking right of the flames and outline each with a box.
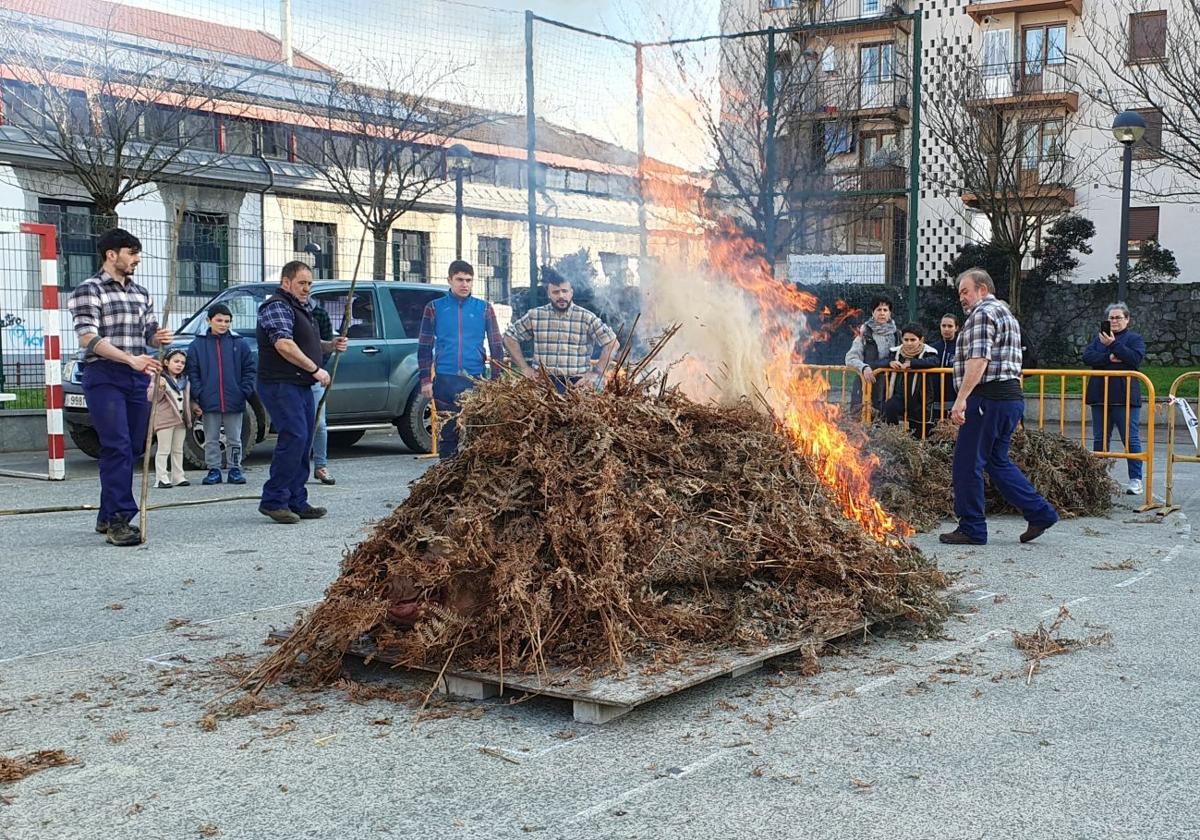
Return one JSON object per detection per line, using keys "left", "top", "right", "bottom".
{"left": 938, "top": 269, "right": 1058, "bottom": 545}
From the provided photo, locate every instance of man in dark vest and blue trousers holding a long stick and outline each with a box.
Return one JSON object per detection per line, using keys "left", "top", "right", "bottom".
{"left": 256, "top": 260, "right": 347, "bottom": 524}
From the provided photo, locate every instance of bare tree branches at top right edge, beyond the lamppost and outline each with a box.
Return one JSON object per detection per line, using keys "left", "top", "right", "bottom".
{"left": 1082, "top": 0, "right": 1200, "bottom": 202}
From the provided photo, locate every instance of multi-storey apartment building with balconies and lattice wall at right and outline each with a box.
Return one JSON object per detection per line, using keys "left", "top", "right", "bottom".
{"left": 725, "top": 0, "right": 1200, "bottom": 284}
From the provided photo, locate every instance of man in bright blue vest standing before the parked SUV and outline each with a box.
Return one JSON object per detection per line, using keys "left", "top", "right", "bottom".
{"left": 416, "top": 259, "right": 504, "bottom": 461}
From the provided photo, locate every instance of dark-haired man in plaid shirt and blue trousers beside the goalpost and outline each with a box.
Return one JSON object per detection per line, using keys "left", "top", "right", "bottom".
{"left": 67, "top": 228, "right": 173, "bottom": 546}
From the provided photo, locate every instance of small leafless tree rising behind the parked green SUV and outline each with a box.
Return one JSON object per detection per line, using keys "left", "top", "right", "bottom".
{"left": 296, "top": 62, "right": 492, "bottom": 280}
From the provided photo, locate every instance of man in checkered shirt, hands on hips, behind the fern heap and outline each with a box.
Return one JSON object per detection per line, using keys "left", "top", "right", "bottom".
{"left": 504, "top": 268, "right": 617, "bottom": 391}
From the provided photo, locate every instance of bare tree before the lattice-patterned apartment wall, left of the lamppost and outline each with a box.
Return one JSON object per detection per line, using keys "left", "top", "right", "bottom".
{"left": 922, "top": 55, "right": 1085, "bottom": 314}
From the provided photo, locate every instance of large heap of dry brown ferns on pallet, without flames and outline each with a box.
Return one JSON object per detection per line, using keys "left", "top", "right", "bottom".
{"left": 245, "top": 369, "right": 946, "bottom": 690}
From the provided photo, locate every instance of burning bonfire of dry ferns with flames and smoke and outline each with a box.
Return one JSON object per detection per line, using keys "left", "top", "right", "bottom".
{"left": 247, "top": 229, "right": 946, "bottom": 689}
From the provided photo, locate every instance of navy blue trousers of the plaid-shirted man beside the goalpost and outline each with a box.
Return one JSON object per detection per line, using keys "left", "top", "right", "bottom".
{"left": 82, "top": 359, "right": 150, "bottom": 522}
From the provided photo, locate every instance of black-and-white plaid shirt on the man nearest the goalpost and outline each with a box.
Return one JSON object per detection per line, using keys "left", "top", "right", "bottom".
{"left": 67, "top": 270, "right": 158, "bottom": 365}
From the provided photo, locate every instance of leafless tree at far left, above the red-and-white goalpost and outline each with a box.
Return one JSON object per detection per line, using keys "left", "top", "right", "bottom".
{"left": 0, "top": 5, "right": 251, "bottom": 224}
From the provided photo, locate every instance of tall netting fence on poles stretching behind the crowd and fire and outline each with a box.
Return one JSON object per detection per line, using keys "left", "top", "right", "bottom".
{"left": 0, "top": 0, "right": 919, "bottom": 404}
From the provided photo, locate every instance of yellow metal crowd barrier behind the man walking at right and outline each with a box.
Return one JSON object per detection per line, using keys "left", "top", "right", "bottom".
{"left": 804, "top": 365, "right": 1152, "bottom": 511}
